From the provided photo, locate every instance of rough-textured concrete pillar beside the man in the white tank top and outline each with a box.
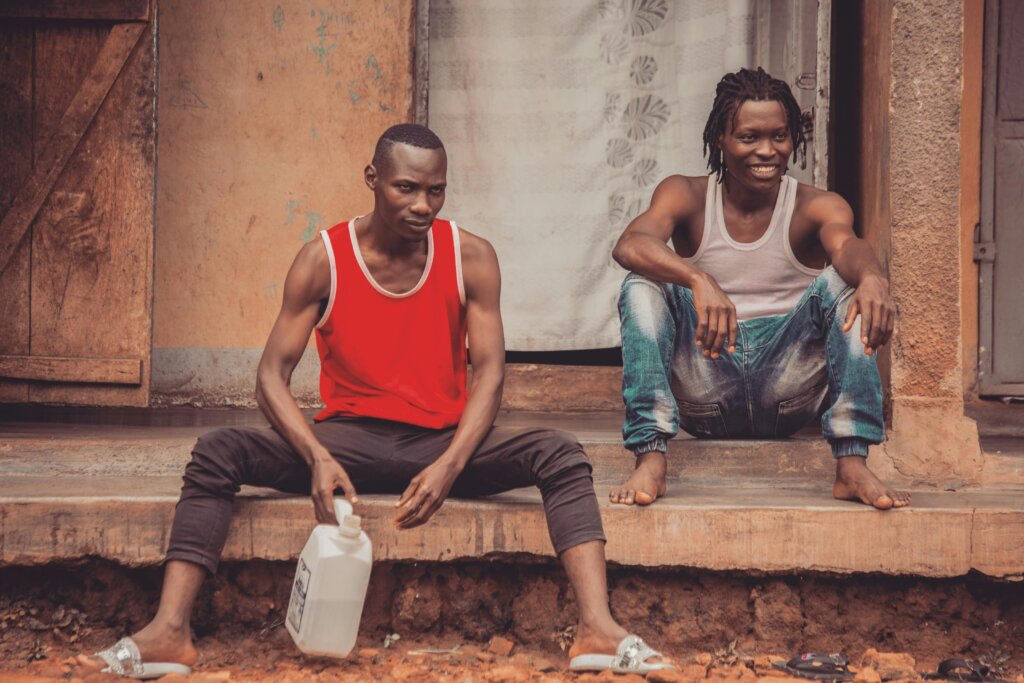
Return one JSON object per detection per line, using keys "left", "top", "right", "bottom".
{"left": 864, "top": 0, "right": 981, "bottom": 486}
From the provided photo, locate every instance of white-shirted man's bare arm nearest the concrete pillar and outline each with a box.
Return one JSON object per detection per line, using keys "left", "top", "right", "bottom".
{"left": 808, "top": 193, "right": 896, "bottom": 355}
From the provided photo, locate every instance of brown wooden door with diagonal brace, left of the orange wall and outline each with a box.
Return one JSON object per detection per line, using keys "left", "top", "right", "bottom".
{"left": 0, "top": 0, "right": 156, "bottom": 405}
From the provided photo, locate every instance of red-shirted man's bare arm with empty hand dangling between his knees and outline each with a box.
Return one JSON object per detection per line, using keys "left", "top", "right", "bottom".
{"left": 395, "top": 231, "right": 505, "bottom": 528}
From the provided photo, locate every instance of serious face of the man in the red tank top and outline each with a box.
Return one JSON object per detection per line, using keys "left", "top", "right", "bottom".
{"left": 366, "top": 142, "right": 447, "bottom": 242}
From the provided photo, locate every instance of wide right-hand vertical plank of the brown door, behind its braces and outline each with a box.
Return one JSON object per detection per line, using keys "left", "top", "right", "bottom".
{"left": 30, "top": 15, "right": 156, "bottom": 405}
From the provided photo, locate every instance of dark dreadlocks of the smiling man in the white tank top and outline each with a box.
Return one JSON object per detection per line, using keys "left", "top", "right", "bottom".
{"left": 703, "top": 67, "right": 807, "bottom": 182}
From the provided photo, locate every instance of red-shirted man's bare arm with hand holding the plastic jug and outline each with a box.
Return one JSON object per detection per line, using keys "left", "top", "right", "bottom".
{"left": 256, "top": 240, "right": 358, "bottom": 522}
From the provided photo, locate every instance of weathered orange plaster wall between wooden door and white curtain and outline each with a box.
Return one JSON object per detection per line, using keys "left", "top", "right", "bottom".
{"left": 153, "top": 0, "right": 415, "bottom": 403}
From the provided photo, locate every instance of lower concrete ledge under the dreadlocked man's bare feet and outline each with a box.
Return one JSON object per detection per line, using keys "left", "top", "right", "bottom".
{"left": 0, "top": 479, "right": 1024, "bottom": 577}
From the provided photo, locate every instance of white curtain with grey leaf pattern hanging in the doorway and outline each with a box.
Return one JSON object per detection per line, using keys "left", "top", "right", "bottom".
{"left": 429, "top": 0, "right": 754, "bottom": 351}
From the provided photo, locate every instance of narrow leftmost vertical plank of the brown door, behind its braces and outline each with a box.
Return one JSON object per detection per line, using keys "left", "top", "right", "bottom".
{"left": 0, "top": 23, "right": 32, "bottom": 402}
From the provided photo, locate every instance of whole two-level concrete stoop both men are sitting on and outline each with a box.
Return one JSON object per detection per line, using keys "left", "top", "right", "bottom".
{"left": 0, "top": 412, "right": 1024, "bottom": 578}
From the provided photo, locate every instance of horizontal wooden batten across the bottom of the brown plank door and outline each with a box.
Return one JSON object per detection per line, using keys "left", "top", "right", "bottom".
{"left": 0, "top": 355, "right": 142, "bottom": 385}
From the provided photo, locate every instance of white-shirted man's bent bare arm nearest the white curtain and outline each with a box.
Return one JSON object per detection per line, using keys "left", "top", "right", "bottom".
{"left": 611, "top": 175, "right": 739, "bottom": 358}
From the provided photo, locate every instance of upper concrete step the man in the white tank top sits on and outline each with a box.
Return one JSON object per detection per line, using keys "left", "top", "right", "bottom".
{"left": 0, "top": 411, "right": 835, "bottom": 487}
